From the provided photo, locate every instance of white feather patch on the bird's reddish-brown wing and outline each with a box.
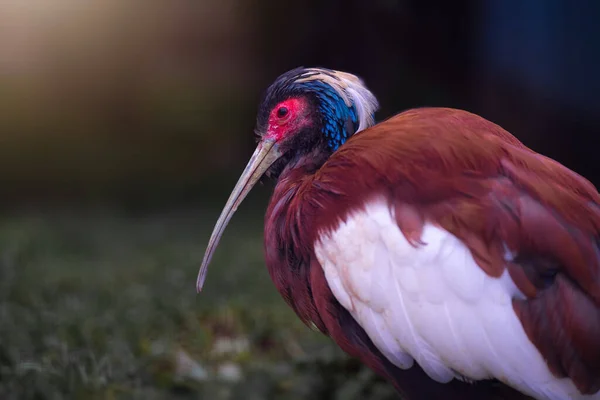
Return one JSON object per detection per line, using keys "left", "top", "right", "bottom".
{"left": 315, "top": 201, "right": 600, "bottom": 400}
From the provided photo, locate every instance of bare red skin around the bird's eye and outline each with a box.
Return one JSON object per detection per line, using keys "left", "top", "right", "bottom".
{"left": 264, "top": 98, "right": 310, "bottom": 142}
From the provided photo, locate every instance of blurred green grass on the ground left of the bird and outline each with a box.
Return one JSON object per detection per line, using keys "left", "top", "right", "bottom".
{"left": 0, "top": 210, "right": 396, "bottom": 400}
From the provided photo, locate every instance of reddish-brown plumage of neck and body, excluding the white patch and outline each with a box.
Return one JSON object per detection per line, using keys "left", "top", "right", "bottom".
{"left": 200, "top": 67, "right": 600, "bottom": 399}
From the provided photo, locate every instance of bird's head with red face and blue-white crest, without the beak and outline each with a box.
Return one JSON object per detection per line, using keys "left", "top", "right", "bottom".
{"left": 256, "top": 68, "right": 378, "bottom": 175}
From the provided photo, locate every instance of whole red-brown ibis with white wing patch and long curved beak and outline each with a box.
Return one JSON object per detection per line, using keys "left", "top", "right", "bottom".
{"left": 196, "top": 67, "right": 600, "bottom": 400}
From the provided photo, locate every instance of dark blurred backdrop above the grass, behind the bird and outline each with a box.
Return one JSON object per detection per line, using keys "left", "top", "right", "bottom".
{"left": 0, "top": 0, "right": 600, "bottom": 207}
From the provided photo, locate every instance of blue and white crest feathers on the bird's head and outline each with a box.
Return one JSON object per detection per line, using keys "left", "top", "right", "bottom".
{"left": 258, "top": 68, "right": 379, "bottom": 151}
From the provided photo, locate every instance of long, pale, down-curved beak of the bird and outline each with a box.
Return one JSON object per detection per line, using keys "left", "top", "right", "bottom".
{"left": 196, "top": 139, "right": 281, "bottom": 292}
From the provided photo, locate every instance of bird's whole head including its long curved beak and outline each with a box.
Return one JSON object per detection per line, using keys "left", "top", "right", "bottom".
{"left": 196, "top": 68, "right": 378, "bottom": 290}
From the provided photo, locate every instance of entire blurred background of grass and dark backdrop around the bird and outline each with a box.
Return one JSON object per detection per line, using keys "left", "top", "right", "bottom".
{"left": 0, "top": 0, "right": 600, "bottom": 399}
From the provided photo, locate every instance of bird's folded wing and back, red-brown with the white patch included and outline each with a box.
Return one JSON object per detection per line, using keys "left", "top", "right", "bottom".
{"left": 305, "top": 109, "right": 600, "bottom": 399}
